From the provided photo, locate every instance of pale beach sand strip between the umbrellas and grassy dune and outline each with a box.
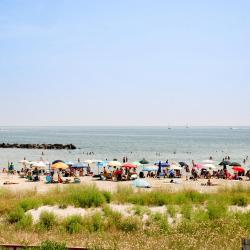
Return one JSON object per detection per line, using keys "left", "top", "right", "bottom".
{"left": 0, "top": 173, "right": 250, "bottom": 193}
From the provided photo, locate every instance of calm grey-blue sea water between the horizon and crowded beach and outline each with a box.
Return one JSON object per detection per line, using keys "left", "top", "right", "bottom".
{"left": 0, "top": 127, "right": 250, "bottom": 167}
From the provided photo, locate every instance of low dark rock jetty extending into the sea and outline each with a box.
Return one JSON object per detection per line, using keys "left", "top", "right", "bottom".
{"left": 0, "top": 143, "right": 76, "bottom": 150}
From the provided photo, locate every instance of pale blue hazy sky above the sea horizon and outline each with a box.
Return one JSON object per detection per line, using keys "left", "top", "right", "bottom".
{"left": 0, "top": 0, "right": 250, "bottom": 125}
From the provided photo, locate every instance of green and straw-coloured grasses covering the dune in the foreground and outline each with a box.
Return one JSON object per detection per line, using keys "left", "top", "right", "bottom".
{"left": 0, "top": 186, "right": 250, "bottom": 249}
